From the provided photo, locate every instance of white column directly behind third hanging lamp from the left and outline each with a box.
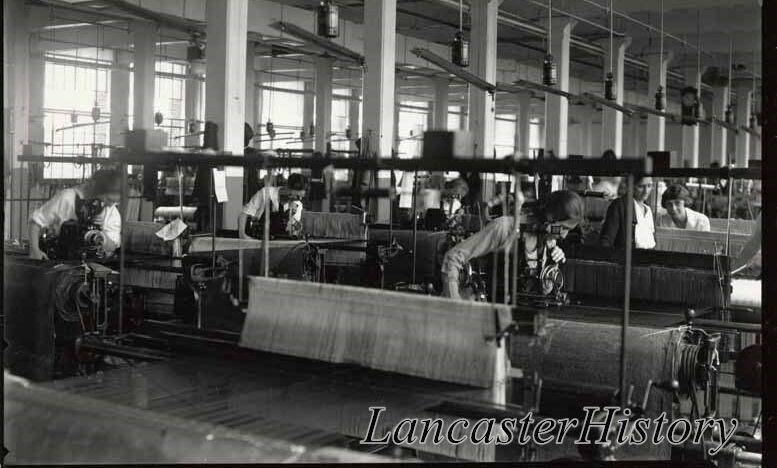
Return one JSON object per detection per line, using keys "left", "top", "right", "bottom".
{"left": 542, "top": 18, "right": 577, "bottom": 158}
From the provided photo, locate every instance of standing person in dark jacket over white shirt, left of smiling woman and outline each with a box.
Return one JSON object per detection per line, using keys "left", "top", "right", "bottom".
{"left": 599, "top": 177, "right": 656, "bottom": 249}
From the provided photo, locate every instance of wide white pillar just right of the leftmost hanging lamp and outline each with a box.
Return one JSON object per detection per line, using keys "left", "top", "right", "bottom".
{"left": 361, "top": 0, "right": 397, "bottom": 222}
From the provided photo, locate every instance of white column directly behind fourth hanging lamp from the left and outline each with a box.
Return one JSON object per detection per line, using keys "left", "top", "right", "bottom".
{"left": 601, "top": 37, "right": 631, "bottom": 158}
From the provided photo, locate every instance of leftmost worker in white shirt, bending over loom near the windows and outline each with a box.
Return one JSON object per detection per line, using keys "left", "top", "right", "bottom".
{"left": 30, "top": 169, "right": 121, "bottom": 260}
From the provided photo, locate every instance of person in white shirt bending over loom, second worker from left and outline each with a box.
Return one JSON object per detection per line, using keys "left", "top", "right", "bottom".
{"left": 237, "top": 174, "right": 307, "bottom": 239}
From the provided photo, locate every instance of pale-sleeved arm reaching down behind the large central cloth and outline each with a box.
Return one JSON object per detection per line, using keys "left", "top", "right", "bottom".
{"left": 442, "top": 216, "right": 515, "bottom": 299}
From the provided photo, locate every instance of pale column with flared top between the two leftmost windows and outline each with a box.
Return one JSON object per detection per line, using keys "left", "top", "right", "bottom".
{"left": 132, "top": 21, "right": 159, "bottom": 130}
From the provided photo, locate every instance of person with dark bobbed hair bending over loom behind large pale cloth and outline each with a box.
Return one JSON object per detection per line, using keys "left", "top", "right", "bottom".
{"left": 442, "top": 190, "right": 585, "bottom": 299}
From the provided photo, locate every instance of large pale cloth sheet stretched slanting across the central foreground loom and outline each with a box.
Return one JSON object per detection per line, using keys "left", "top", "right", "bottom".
{"left": 240, "top": 277, "right": 510, "bottom": 388}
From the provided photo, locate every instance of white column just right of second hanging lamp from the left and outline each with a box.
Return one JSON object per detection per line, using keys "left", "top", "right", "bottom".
{"left": 469, "top": 0, "right": 502, "bottom": 158}
